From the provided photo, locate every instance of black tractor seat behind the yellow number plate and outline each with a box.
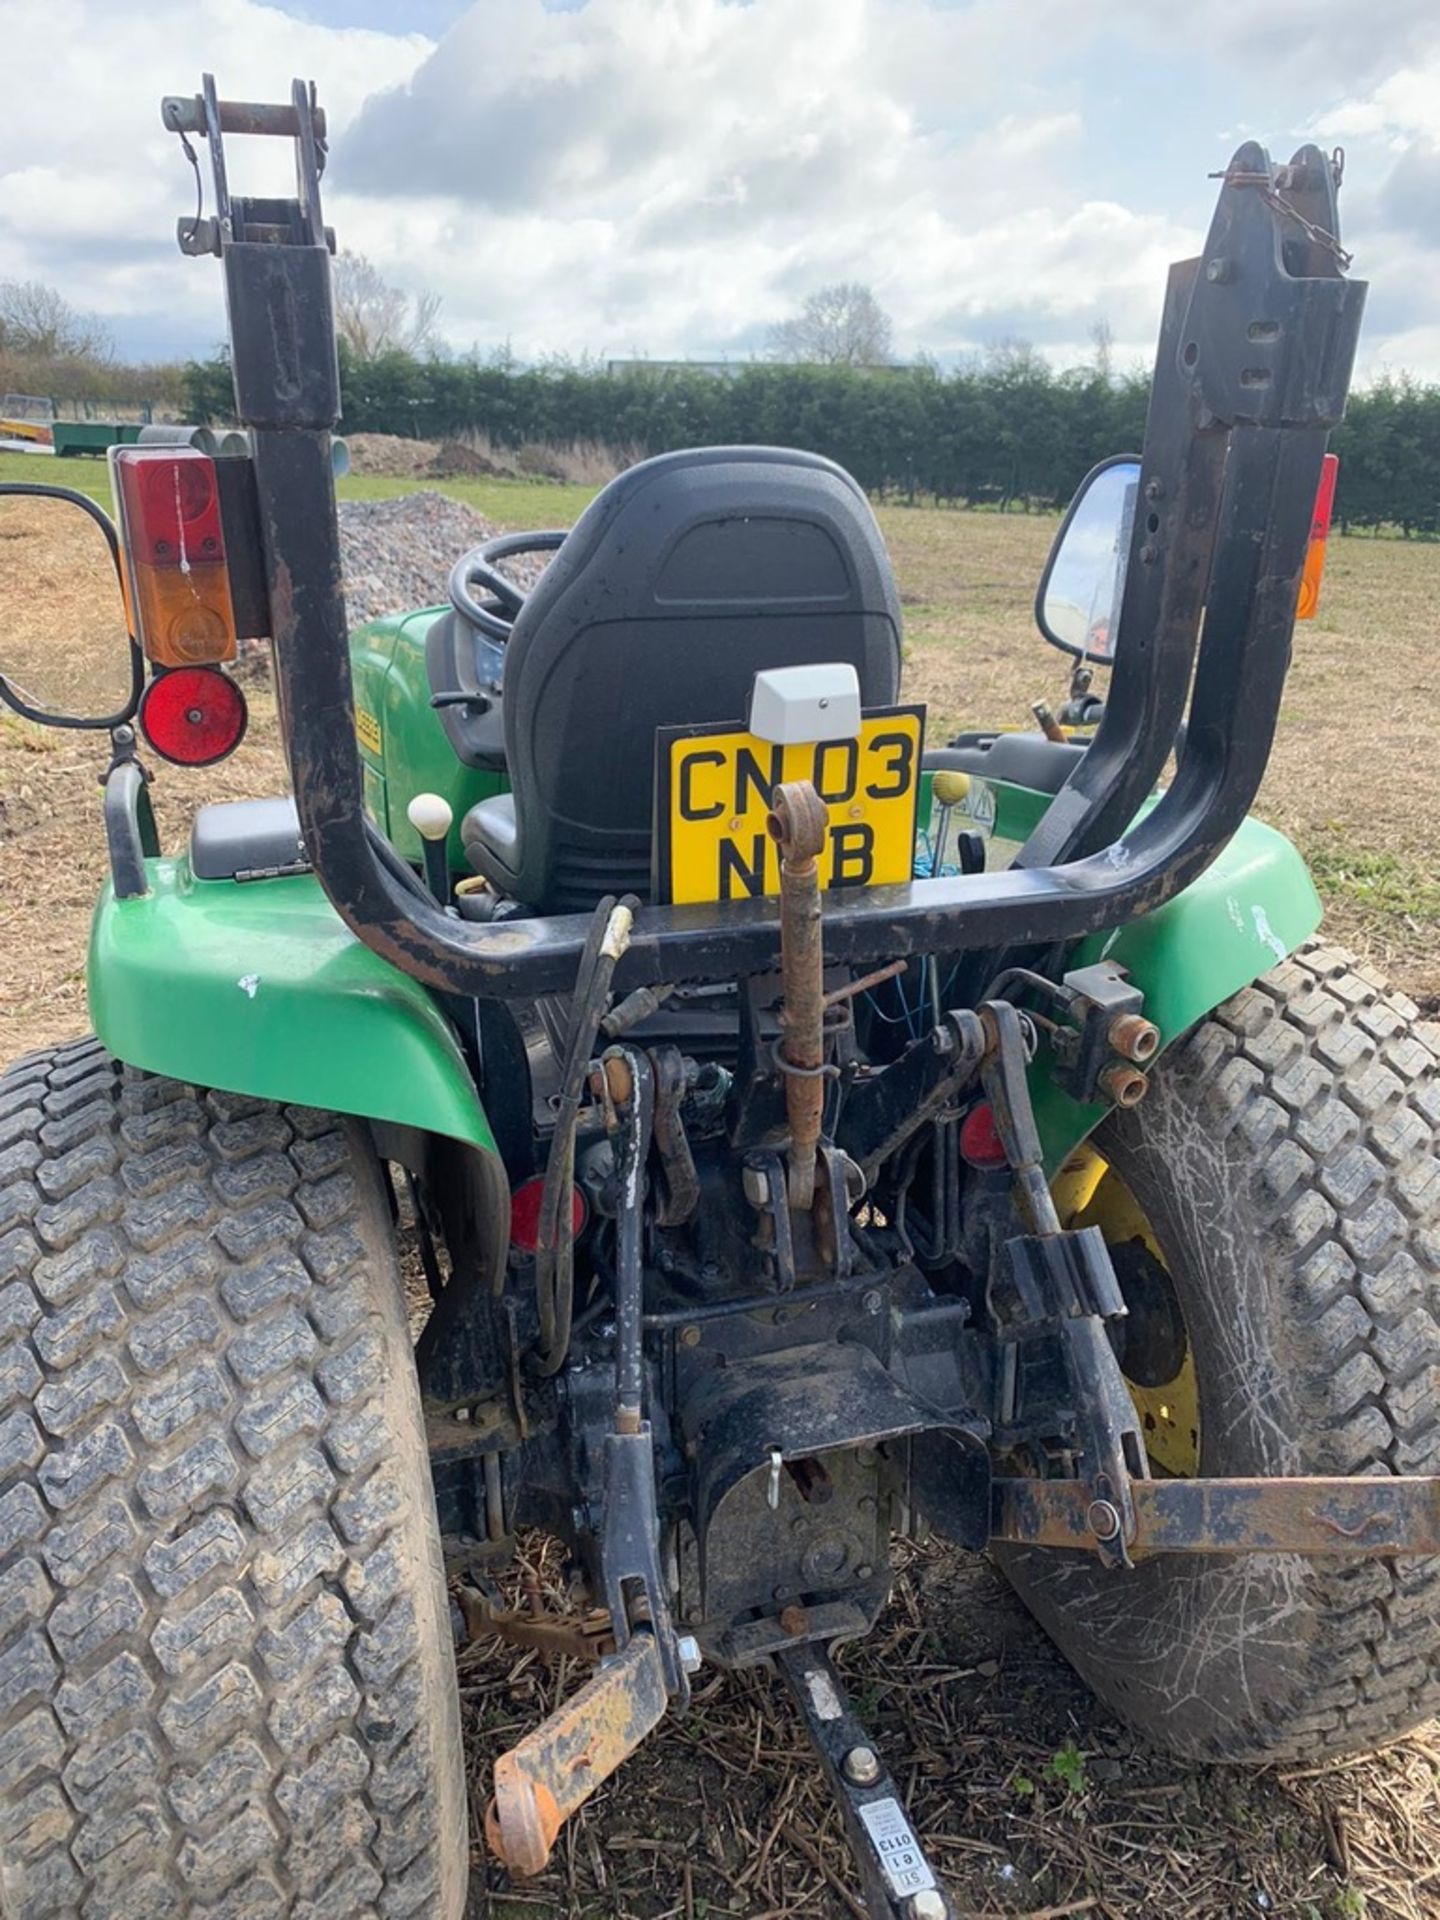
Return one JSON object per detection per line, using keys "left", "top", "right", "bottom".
{"left": 463, "top": 447, "right": 900, "bottom": 912}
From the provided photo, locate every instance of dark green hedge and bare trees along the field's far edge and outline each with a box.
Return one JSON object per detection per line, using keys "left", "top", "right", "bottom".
{"left": 0, "top": 266, "right": 1440, "bottom": 536}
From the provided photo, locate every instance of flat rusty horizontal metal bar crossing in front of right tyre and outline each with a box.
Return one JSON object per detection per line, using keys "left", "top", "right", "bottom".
{"left": 991, "top": 1475, "right": 1440, "bottom": 1557}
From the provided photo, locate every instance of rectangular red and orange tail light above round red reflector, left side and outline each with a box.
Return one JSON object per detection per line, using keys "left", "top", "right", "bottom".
{"left": 109, "top": 447, "right": 244, "bottom": 668}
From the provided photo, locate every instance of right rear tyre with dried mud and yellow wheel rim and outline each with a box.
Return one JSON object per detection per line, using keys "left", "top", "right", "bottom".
{"left": 998, "top": 945, "right": 1440, "bottom": 1761}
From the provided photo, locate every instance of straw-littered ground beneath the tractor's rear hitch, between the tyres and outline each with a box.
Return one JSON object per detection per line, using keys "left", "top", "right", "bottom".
{"left": 459, "top": 1542, "right": 1440, "bottom": 1920}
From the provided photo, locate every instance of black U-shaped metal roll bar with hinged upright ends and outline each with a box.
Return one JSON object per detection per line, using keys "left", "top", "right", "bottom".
{"left": 167, "top": 75, "right": 1365, "bottom": 998}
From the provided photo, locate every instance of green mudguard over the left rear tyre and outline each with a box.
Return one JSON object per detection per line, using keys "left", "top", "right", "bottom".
{"left": 88, "top": 860, "right": 495, "bottom": 1152}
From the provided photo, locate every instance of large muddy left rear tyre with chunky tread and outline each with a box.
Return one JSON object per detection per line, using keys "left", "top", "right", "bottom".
{"left": 0, "top": 1041, "right": 467, "bottom": 1920}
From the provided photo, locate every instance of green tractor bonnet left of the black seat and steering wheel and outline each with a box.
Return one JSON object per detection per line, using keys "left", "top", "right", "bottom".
{"left": 349, "top": 607, "right": 509, "bottom": 874}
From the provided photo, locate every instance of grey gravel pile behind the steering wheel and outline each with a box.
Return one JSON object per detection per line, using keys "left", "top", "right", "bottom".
{"left": 340, "top": 492, "right": 547, "bottom": 628}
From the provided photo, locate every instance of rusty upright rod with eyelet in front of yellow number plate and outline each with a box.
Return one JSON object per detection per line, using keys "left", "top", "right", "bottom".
{"left": 764, "top": 780, "right": 829, "bottom": 1210}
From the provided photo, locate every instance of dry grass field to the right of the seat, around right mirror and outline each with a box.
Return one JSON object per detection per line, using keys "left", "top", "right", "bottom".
{"left": 879, "top": 507, "right": 1440, "bottom": 1008}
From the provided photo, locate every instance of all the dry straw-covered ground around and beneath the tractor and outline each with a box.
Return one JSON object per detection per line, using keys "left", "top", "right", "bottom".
{"left": 0, "top": 488, "right": 1440, "bottom": 1920}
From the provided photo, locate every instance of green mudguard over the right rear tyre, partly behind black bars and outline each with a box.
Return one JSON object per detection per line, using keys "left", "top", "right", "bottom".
{"left": 956, "top": 780, "right": 1321, "bottom": 1167}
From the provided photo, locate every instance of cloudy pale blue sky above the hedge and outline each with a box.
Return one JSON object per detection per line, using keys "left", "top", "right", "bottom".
{"left": 0, "top": 0, "right": 1440, "bottom": 380}
